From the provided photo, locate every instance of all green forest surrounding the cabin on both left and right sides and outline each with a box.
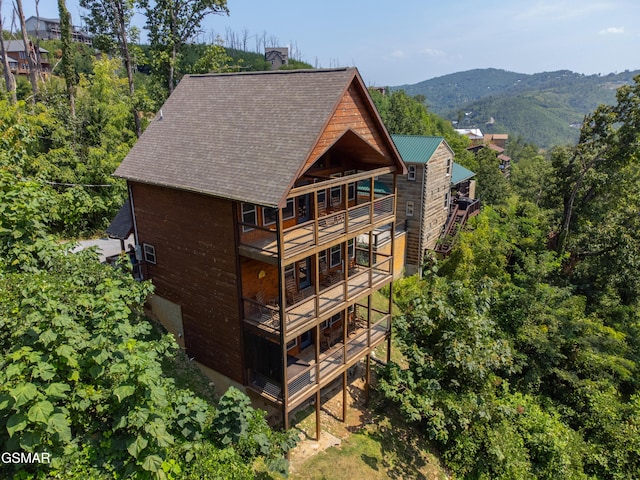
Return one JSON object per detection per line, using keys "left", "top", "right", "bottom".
{"left": 0, "top": 0, "right": 640, "bottom": 479}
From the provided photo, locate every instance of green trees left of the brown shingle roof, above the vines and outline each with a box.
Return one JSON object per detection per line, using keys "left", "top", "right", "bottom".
{"left": 0, "top": 60, "right": 135, "bottom": 236}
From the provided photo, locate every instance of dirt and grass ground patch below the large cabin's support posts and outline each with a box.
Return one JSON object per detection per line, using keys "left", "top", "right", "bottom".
{"left": 289, "top": 362, "right": 451, "bottom": 480}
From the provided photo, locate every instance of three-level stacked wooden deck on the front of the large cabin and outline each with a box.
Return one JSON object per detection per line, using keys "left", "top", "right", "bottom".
{"left": 239, "top": 169, "right": 395, "bottom": 411}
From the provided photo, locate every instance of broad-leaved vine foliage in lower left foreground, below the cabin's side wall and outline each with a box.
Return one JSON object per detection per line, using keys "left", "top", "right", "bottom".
{"left": 0, "top": 218, "right": 295, "bottom": 479}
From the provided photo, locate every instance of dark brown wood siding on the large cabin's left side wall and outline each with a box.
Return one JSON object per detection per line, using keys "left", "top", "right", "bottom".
{"left": 131, "top": 183, "right": 244, "bottom": 383}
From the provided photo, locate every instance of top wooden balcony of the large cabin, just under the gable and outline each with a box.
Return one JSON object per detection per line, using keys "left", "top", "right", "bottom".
{"left": 239, "top": 194, "right": 395, "bottom": 263}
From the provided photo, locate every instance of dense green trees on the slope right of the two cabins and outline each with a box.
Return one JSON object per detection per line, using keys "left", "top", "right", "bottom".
{"left": 374, "top": 81, "right": 640, "bottom": 479}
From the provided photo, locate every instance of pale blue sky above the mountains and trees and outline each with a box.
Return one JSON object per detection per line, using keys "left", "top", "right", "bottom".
{"left": 2, "top": 0, "right": 640, "bottom": 86}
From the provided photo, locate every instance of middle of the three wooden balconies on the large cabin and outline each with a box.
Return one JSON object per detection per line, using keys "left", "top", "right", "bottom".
{"left": 243, "top": 254, "right": 393, "bottom": 341}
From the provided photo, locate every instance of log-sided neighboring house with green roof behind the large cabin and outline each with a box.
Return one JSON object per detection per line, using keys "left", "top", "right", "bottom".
{"left": 392, "top": 135, "right": 454, "bottom": 275}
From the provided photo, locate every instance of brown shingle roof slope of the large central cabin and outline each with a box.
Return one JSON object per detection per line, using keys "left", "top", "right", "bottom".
{"left": 115, "top": 68, "right": 378, "bottom": 206}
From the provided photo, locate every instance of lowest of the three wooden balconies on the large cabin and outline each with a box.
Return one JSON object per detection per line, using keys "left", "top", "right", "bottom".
{"left": 249, "top": 310, "right": 391, "bottom": 409}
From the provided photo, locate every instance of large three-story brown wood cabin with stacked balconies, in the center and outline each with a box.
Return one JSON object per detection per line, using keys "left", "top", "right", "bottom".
{"left": 115, "top": 68, "right": 406, "bottom": 434}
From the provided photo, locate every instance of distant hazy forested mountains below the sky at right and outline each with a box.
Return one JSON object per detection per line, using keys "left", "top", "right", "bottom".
{"left": 392, "top": 69, "right": 640, "bottom": 148}
